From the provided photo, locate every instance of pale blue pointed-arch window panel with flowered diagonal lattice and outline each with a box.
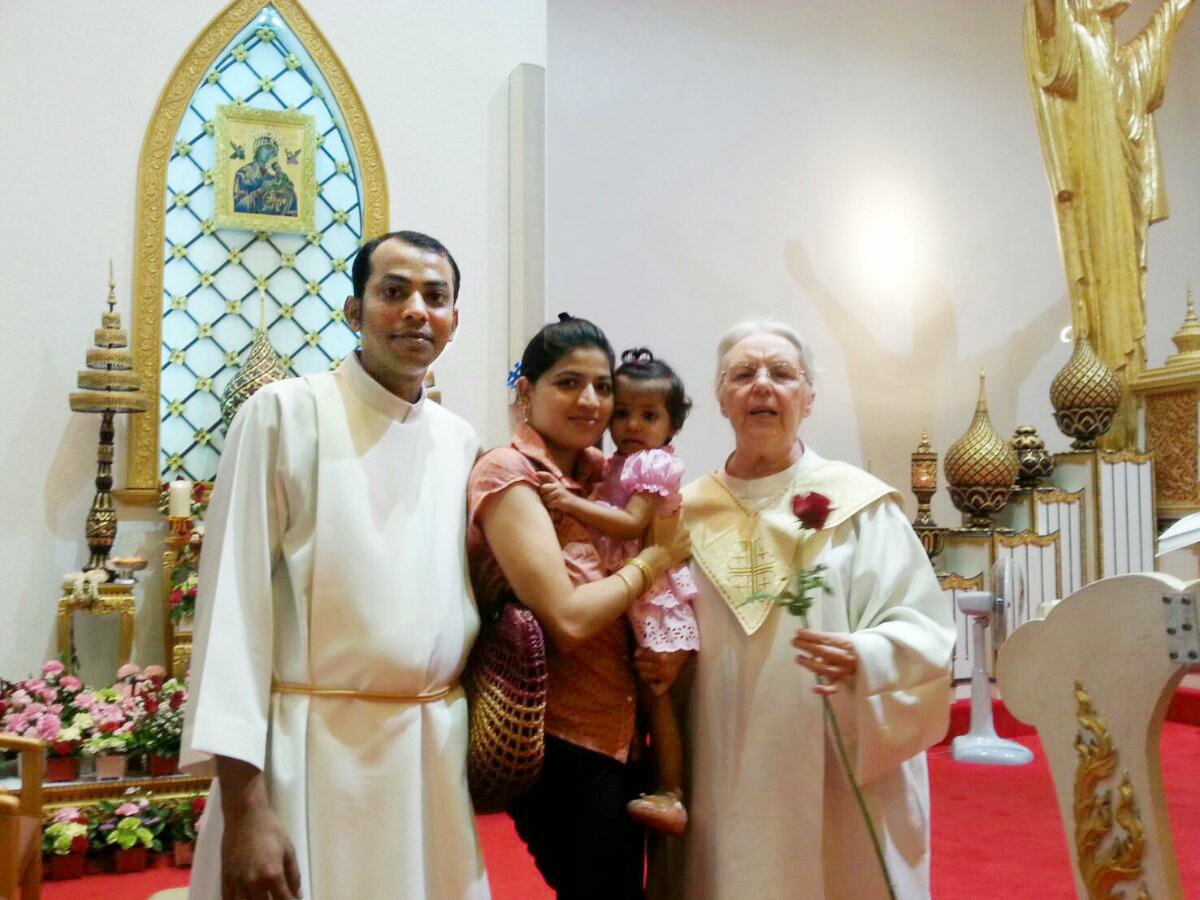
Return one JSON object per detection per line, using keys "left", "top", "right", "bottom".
{"left": 160, "top": 7, "right": 362, "bottom": 480}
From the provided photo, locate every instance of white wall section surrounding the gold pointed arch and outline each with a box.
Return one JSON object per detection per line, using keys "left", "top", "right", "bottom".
{"left": 0, "top": 0, "right": 546, "bottom": 678}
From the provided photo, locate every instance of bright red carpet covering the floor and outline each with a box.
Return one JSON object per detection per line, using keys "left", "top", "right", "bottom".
{"left": 43, "top": 691, "right": 1200, "bottom": 900}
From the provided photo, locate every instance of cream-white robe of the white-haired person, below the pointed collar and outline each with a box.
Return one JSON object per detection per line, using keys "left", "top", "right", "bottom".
{"left": 668, "top": 449, "right": 955, "bottom": 900}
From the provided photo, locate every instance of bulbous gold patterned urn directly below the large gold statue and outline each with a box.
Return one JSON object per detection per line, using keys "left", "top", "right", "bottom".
{"left": 1050, "top": 312, "right": 1121, "bottom": 450}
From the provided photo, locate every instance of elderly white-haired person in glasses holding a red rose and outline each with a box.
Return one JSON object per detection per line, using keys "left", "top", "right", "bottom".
{"left": 640, "top": 322, "right": 954, "bottom": 900}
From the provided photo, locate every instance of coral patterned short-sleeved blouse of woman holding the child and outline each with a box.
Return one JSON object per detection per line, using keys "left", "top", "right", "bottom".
{"left": 467, "top": 425, "right": 636, "bottom": 762}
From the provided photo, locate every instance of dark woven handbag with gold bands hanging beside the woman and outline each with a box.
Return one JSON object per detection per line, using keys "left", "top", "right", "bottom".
{"left": 462, "top": 599, "right": 546, "bottom": 812}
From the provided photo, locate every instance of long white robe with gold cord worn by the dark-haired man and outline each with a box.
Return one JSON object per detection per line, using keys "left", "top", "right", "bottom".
{"left": 182, "top": 355, "right": 488, "bottom": 900}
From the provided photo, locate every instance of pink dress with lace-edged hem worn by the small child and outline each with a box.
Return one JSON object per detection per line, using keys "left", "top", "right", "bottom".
{"left": 595, "top": 446, "right": 700, "bottom": 652}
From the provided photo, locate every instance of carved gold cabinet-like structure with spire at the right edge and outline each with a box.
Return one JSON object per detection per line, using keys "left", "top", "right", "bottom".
{"left": 1133, "top": 290, "right": 1200, "bottom": 520}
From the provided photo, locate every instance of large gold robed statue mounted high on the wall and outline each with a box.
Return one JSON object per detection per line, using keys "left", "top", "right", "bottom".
{"left": 1025, "top": 0, "right": 1193, "bottom": 448}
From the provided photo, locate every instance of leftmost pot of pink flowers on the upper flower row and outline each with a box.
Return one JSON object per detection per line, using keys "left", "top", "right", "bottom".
{"left": 0, "top": 660, "right": 88, "bottom": 781}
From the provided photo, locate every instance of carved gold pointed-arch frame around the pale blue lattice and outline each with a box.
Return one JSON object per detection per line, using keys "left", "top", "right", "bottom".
{"left": 115, "top": 0, "right": 388, "bottom": 504}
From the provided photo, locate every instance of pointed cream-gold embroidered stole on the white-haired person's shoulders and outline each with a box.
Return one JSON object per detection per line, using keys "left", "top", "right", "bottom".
{"left": 680, "top": 462, "right": 899, "bottom": 635}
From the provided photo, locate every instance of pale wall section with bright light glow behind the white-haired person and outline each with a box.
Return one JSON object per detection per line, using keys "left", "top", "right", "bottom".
{"left": 547, "top": 0, "right": 1200, "bottom": 547}
